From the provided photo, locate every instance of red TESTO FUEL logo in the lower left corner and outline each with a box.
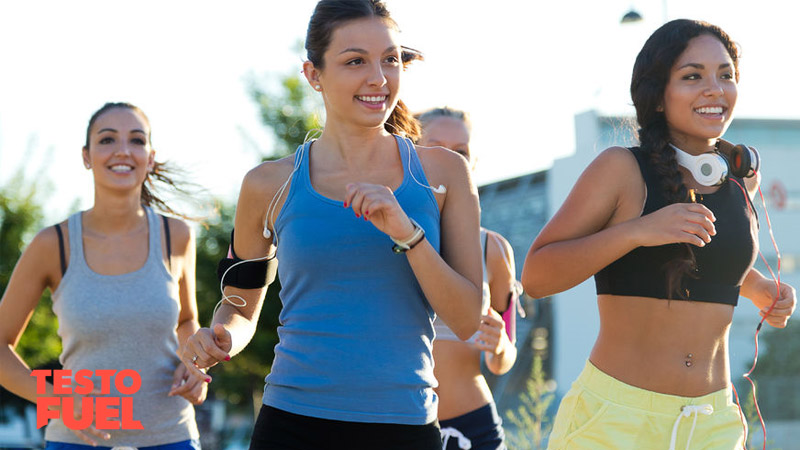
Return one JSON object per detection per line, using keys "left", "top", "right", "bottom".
{"left": 31, "top": 369, "right": 144, "bottom": 430}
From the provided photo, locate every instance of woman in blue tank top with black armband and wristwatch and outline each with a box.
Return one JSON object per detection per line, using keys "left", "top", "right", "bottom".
{"left": 182, "top": 0, "right": 481, "bottom": 450}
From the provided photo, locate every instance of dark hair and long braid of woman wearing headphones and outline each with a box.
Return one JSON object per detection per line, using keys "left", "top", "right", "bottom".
{"left": 631, "top": 19, "right": 739, "bottom": 298}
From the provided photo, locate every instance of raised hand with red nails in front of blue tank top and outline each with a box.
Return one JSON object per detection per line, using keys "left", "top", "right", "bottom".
{"left": 344, "top": 183, "right": 414, "bottom": 239}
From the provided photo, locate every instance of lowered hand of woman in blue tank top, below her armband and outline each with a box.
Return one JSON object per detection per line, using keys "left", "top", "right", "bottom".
{"left": 178, "top": 324, "right": 233, "bottom": 383}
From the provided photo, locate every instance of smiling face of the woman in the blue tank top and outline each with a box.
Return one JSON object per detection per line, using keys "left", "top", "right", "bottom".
{"left": 304, "top": 17, "right": 403, "bottom": 128}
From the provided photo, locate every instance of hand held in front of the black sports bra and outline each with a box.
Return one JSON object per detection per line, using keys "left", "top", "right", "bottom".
{"left": 635, "top": 203, "right": 717, "bottom": 247}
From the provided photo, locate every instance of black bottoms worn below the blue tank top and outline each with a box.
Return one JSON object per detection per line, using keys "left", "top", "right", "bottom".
{"left": 250, "top": 405, "right": 442, "bottom": 450}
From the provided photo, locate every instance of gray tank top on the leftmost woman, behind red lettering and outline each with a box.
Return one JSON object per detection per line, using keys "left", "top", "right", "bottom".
{"left": 45, "top": 207, "right": 199, "bottom": 447}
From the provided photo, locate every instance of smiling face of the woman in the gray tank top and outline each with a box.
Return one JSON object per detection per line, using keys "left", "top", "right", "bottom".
{"left": 83, "top": 108, "right": 155, "bottom": 195}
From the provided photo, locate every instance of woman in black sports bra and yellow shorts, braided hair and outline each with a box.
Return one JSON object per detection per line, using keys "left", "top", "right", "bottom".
{"left": 522, "top": 20, "right": 796, "bottom": 449}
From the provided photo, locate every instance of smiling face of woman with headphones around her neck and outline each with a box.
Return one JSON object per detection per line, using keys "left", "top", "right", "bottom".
{"left": 663, "top": 34, "right": 737, "bottom": 154}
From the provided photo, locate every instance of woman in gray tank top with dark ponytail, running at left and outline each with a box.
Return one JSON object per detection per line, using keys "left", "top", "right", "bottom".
{"left": 0, "top": 103, "right": 203, "bottom": 449}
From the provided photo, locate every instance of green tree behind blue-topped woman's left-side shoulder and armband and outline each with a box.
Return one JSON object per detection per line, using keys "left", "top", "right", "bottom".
{"left": 192, "top": 70, "right": 321, "bottom": 409}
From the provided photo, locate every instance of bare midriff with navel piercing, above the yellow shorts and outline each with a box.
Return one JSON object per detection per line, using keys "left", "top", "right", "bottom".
{"left": 589, "top": 295, "right": 733, "bottom": 397}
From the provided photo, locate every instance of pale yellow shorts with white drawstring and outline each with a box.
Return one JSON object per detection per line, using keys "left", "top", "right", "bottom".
{"left": 547, "top": 361, "right": 744, "bottom": 450}
